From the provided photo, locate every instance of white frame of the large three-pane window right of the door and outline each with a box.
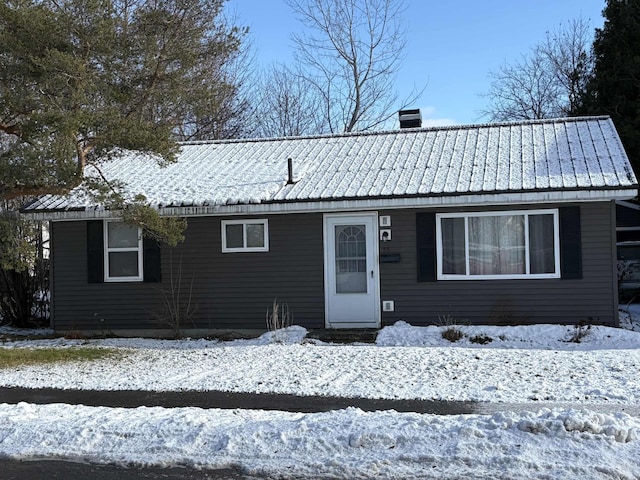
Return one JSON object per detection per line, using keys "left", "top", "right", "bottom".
{"left": 436, "top": 208, "right": 560, "bottom": 280}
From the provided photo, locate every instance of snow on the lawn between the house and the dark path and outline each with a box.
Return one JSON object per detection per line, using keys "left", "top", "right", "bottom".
{"left": 0, "top": 322, "right": 640, "bottom": 404}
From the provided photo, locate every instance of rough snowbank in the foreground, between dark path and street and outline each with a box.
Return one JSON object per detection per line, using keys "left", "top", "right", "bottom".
{"left": 0, "top": 404, "right": 640, "bottom": 479}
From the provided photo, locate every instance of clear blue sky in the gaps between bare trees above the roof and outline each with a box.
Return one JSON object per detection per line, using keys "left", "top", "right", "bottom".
{"left": 227, "top": 0, "right": 605, "bottom": 126}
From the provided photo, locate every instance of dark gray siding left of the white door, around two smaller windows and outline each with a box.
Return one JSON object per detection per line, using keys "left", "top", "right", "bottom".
{"left": 52, "top": 214, "right": 324, "bottom": 331}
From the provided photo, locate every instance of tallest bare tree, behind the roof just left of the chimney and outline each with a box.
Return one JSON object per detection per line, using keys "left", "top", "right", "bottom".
{"left": 287, "top": 0, "right": 417, "bottom": 132}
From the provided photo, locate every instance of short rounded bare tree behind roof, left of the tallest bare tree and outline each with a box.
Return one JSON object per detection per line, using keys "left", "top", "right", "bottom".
{"left": 254, "top": 64, "right": 323, "bottom": 137}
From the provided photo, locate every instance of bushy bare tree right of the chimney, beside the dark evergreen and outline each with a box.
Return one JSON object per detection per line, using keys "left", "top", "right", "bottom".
{"left": 481, "top": 18, "right": 593, "bottom": 121}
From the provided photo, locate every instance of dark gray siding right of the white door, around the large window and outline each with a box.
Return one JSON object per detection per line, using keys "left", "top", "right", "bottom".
{"left": 380, "top": 202, "right": 617, "bottom": 325}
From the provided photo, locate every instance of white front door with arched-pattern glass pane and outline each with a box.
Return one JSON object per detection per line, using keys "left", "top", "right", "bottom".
{"left": 324, "top": 213, "right": 380, "bottom": 328}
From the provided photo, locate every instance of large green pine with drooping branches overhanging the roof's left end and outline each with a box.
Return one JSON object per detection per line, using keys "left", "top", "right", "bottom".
{"left": 0, "top": 0, "right": 244, "bottom": 243}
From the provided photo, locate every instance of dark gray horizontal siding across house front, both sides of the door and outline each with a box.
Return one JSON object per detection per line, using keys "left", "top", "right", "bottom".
{"left": 52, "top": 202, "right": 617, "bottom": 332}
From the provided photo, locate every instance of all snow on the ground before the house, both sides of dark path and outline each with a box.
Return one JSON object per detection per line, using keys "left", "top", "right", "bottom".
{"left": 0, "top": 309, "right": 640, "bottom": 479}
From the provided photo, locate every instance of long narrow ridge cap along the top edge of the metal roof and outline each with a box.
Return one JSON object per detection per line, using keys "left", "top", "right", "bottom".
{"left": 178, "top": 115, "right": 610, "bottom": 145}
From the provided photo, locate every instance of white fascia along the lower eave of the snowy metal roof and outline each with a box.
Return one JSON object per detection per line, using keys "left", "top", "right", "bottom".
{"left": 22, "top": 188, "right": 638, "bottom": 221}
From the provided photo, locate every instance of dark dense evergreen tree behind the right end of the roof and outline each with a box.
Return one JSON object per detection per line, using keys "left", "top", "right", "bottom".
{"left": 572, "top": 0, "right": 640, "bottom": 174}
